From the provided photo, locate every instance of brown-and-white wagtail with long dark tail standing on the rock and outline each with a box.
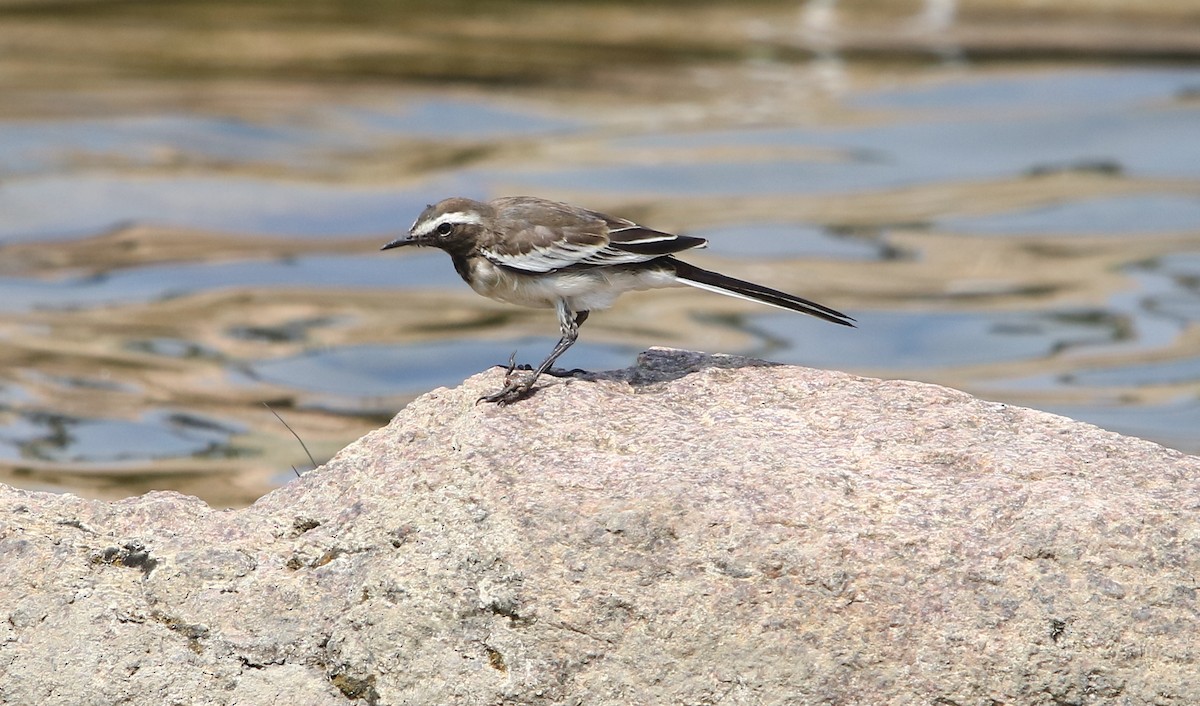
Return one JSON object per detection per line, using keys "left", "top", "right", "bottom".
{"left": 380, "top": 196, "right": 854, "bottom": 406}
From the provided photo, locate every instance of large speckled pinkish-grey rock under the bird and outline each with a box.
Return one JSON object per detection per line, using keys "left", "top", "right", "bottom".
{"left": 0, "top": 349, "right": 1200, "bottom": 706}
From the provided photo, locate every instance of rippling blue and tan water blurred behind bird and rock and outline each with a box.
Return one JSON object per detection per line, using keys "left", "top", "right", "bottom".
{"left": 0, "top": 0, "right": 1200, "bottom": 505}
